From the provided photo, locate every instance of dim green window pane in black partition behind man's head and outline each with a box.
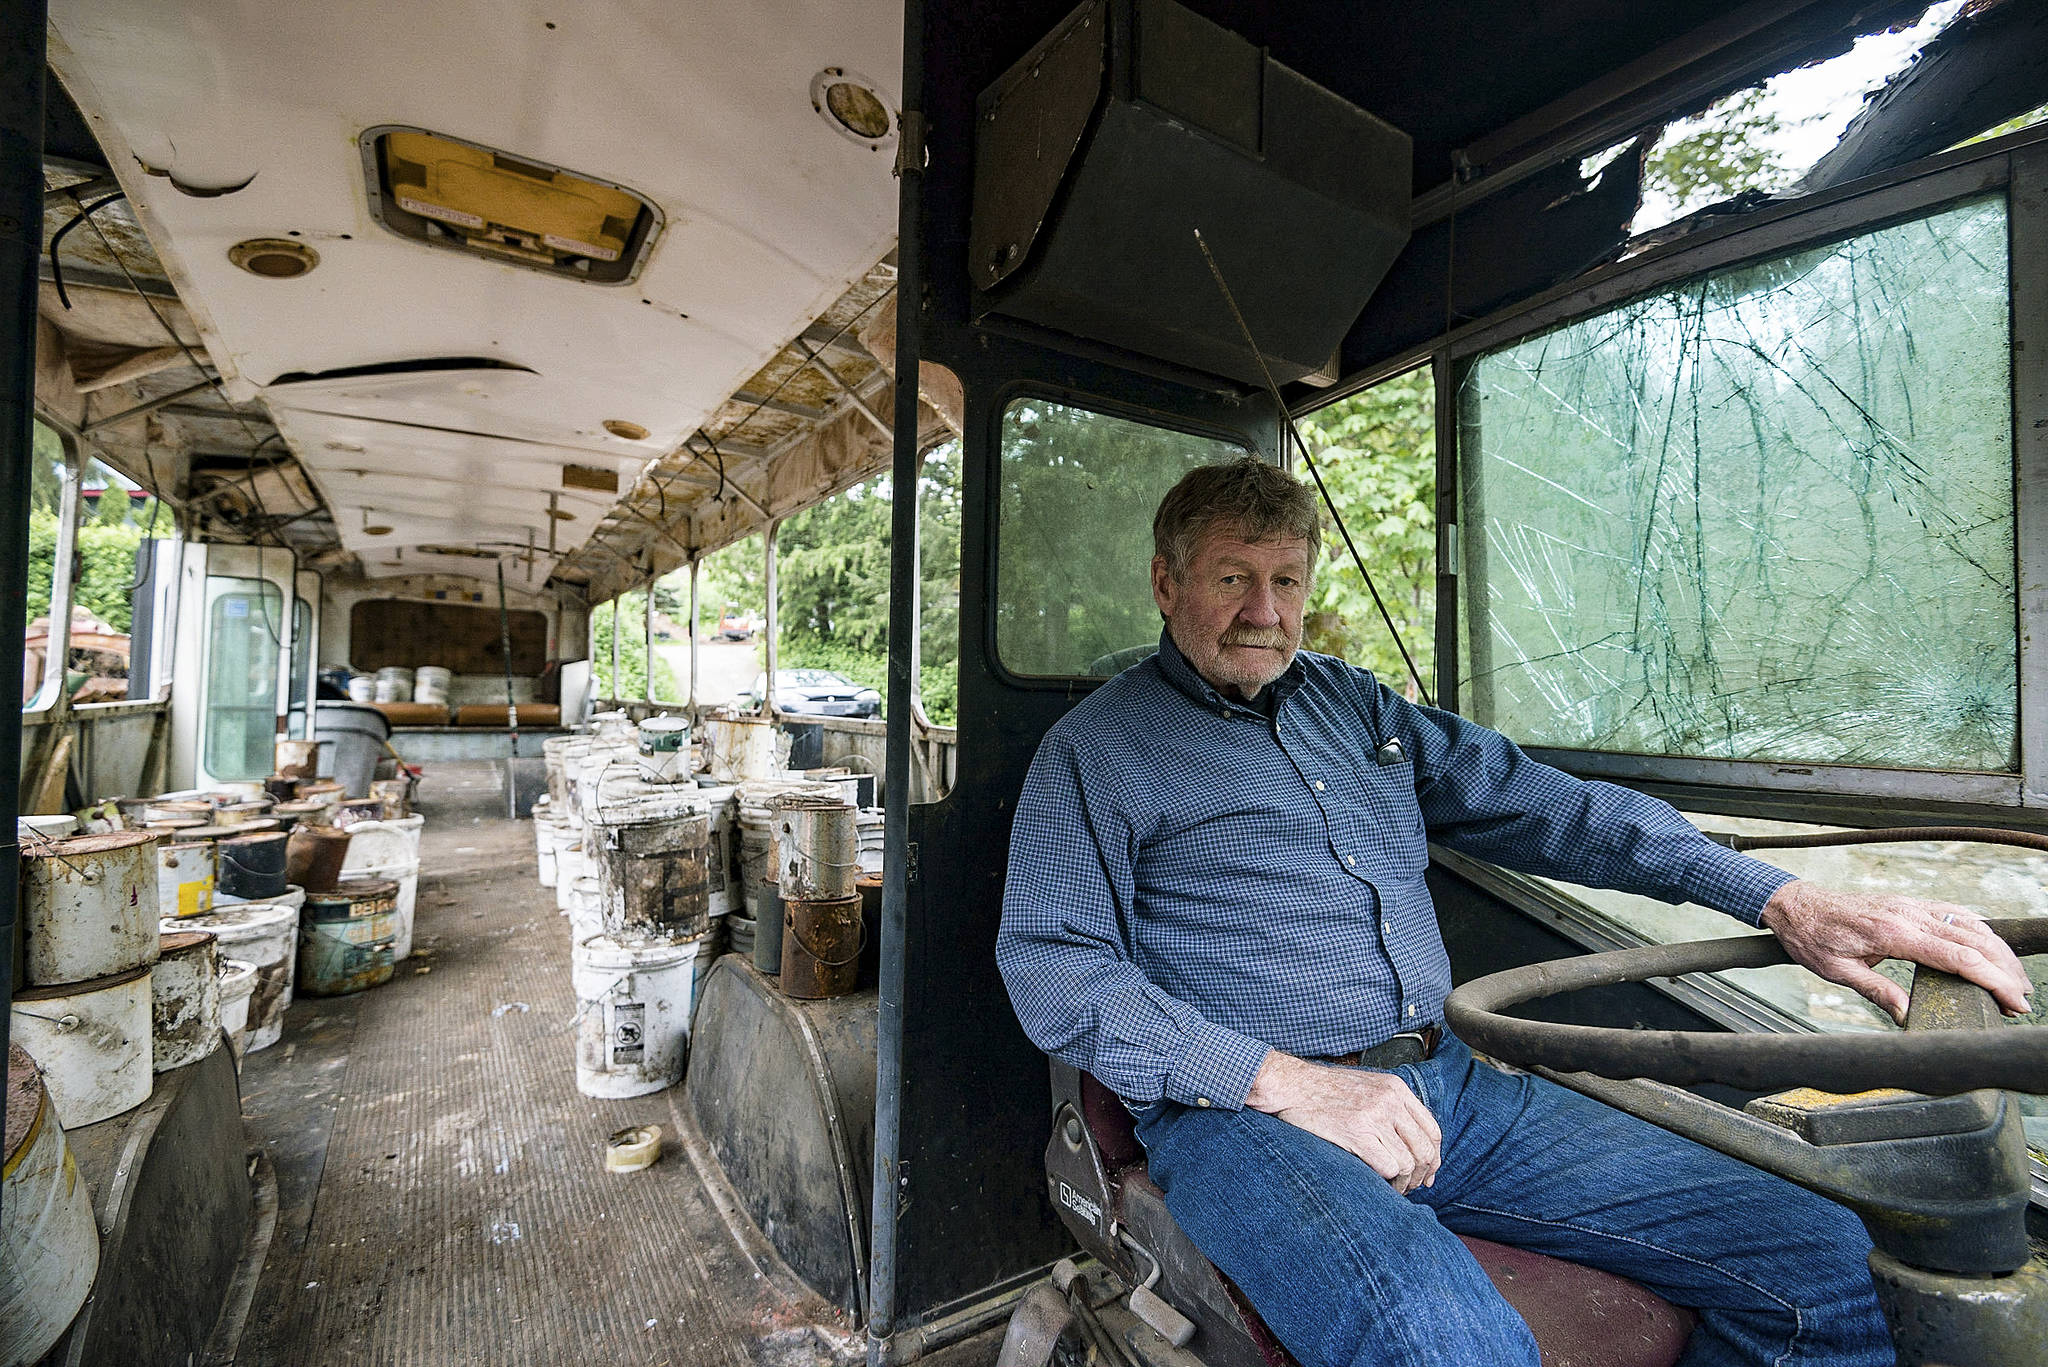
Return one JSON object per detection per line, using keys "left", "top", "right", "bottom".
{"left": 995, "top": 398, "right": 1245, "bottom": 678}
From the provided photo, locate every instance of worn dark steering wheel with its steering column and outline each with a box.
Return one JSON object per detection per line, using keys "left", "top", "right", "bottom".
{"left": 1444, "top": 916, "right": 2048, "bottom": 1367}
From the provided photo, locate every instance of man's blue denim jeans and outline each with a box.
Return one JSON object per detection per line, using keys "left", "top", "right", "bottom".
{"left": 1137, "top": 1037, "right": 1894, "bottom": 1367}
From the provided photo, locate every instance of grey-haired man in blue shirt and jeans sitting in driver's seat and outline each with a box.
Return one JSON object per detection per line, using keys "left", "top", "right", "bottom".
{"left": 997, "top": 459, "right": 2030, "bottom": 1367}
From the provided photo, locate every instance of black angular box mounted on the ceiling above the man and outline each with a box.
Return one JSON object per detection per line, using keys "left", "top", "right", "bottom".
{"left": 969, "top": 0, "right": 1413, "bottom": 385}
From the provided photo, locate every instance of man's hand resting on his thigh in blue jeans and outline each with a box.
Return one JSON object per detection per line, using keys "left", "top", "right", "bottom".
{"left": 1245, "top": 1049, "right": 1444, "bottom": 1195}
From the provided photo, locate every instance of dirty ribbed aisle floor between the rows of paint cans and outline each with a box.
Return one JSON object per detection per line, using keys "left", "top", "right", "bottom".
{"left": 236, "top": 764, "right": 858, "bottom": 1367}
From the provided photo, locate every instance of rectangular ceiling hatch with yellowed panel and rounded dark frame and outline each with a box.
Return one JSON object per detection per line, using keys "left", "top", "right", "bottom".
{"left": 358, "top": 125, "right": 662, "bottom": 285}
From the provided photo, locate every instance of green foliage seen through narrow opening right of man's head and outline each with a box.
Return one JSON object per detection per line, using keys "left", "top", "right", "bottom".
{"left": 1300, "top": 367, "right": 1436, "bottom": 697}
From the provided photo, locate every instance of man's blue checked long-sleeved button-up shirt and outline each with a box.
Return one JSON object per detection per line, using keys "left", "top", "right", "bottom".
{"left": 995, "top": 635, "right": 1792, "bottom": 1109}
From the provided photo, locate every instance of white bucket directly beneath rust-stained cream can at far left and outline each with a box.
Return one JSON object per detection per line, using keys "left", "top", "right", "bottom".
{"left": 12, "top": 967, "right": 154, "bottom": 1129}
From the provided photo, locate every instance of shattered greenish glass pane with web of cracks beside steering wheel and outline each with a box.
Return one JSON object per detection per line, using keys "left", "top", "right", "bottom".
{"left": 1458, "top": 197, "right": 2017, "bottom": 771}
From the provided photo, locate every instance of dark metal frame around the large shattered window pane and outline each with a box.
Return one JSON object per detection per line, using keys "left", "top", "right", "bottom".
{"left": 1425, "top": 143, "right": 2048, "bottom": 824}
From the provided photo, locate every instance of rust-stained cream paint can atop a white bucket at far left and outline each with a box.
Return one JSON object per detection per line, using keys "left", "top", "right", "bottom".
{"left": 20, "top": 830, "right": 162, "bottom": 988}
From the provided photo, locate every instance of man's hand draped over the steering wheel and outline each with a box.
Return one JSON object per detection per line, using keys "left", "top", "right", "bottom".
{"left": 1763, "top": 879, "right": 2034, "bottom": 1025}
